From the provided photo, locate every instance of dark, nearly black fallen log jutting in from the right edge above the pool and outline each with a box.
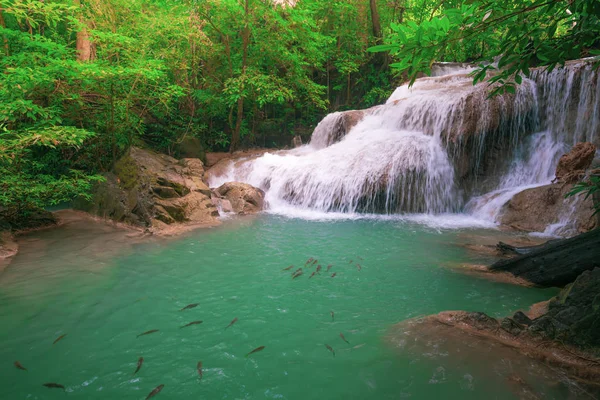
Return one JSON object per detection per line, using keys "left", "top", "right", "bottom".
{"left": 489, "top": 229, "right": 600, "bottom": 287}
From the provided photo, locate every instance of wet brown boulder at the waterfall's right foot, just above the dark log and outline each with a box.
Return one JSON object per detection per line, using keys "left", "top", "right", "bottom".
{"left": 500, "top": 183, "right": 598, "bottom": 233}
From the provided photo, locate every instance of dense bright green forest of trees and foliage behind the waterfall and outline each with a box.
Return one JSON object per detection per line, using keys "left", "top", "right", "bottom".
{"left": 0, "top": 0, "right": 600, "bottom": 219}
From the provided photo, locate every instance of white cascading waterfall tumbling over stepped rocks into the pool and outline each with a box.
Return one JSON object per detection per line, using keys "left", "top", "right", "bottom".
{"left": 209, "top": 63, "right": 600, "bottom": 233}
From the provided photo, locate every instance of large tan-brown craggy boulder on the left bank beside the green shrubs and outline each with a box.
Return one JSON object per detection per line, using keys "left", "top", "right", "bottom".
{"left": 75, "top": 147, "right": 219, "bottom": 233}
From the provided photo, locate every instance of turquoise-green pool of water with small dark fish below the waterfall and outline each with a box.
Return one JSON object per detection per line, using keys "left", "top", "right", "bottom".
{"left": 0, "top": 215, "right": 556, "bottom": 399}
